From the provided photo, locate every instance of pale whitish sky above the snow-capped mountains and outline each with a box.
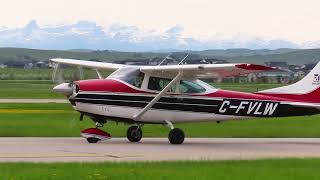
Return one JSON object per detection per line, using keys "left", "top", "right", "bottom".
{"left": 0, "top": 0, "right": 320, "bottom": 43}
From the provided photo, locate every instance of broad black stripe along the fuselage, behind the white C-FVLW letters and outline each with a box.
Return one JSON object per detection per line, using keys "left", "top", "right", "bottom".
{"left": 73, "top": 93, "right": 319, "bottom": 117}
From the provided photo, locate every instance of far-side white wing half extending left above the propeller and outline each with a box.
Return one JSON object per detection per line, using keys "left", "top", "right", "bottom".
{"left": 51, "top": 58, "right": 126, "bottom": 70}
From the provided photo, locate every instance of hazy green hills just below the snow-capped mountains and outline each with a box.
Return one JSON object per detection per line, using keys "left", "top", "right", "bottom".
{"left": 0, "top": 48, "right": 320, "bottom": 64}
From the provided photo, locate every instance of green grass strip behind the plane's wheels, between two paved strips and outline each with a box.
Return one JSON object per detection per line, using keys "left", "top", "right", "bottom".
{"left": 0, "top": 104, "right": 320, "bottom": 137}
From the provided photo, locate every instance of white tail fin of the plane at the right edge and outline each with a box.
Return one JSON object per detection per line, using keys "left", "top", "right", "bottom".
{"left": 258, "top": 62, "right": 320, "bottom": 95}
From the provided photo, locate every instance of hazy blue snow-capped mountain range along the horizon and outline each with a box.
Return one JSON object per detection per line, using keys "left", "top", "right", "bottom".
{"left": 0, "top": 20, "right": 304, "bottom": 51}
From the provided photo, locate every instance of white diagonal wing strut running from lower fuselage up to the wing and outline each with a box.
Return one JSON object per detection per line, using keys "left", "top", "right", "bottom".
{"left": 133, "top": 72, "right": 182, "bottom": 121}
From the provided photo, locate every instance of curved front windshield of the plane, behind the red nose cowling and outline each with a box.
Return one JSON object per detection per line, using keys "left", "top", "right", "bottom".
{"left": 108, "top": 68, "right": 144, "bottom": 88}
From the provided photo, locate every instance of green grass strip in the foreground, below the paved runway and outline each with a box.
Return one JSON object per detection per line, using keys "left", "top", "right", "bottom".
{"left": 0, "top": 159, "right": 320, "bottom": 180}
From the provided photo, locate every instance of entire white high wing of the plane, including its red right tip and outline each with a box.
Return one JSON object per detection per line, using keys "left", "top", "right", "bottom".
{"left": 51, "top": 58, "right": 274, "bottom": 78}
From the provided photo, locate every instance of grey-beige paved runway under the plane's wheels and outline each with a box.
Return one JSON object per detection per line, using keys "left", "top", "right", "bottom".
{"left": 0, "top": 138, "right": 320, "bottom": 162}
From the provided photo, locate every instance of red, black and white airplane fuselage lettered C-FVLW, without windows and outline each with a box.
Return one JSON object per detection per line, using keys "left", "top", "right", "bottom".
{"left": 69, "top": 78, "right": 319, "bottom": 123}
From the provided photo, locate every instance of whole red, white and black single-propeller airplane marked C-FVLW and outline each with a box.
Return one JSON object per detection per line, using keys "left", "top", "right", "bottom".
{"left": 51, "top": 59, "right": 320, "bottom": 144}
